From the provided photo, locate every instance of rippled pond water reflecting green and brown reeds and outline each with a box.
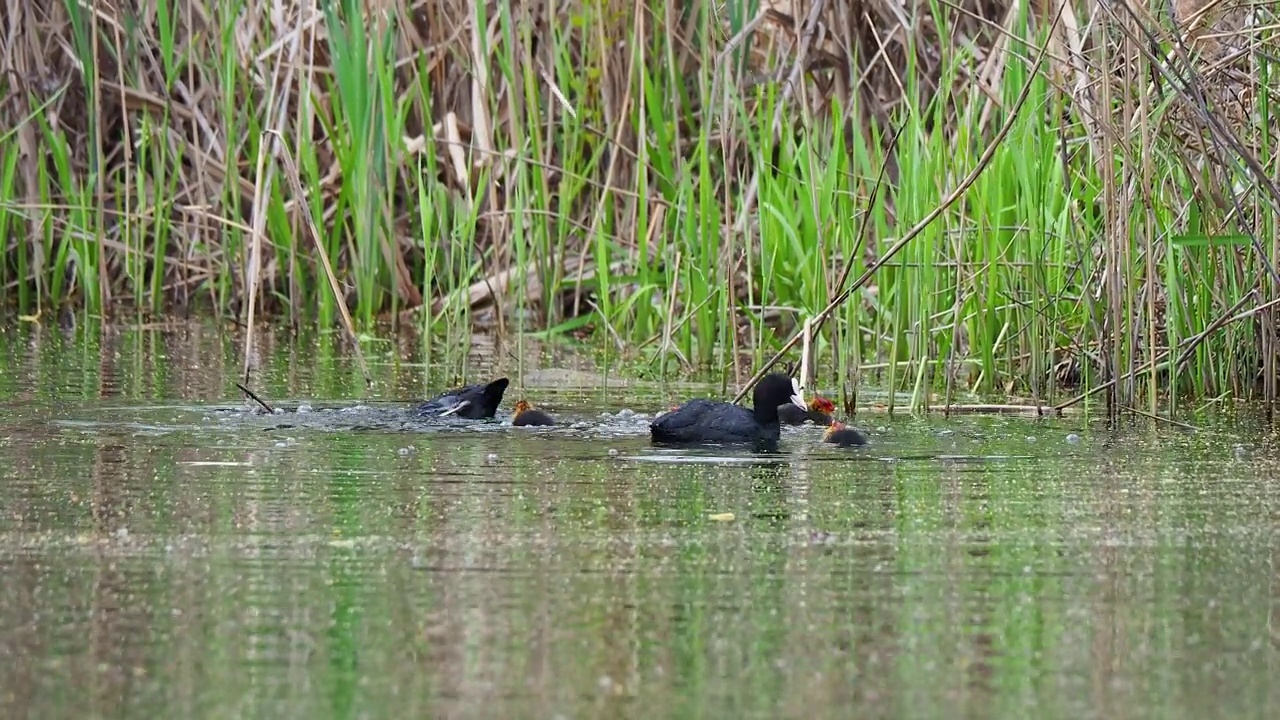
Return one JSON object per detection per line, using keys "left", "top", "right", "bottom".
{"left": 0, "top": 324, "right": 1280, "bottom": 719}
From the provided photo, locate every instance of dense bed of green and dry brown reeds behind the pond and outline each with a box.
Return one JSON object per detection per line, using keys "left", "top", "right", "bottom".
{"left": 0, "top": 0, "right": 1280, "bottom": 414}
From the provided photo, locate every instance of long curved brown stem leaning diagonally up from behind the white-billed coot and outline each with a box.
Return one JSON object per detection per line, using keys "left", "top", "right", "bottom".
{"left": 733, "top": 0, "right": 1062, "bottom": 402}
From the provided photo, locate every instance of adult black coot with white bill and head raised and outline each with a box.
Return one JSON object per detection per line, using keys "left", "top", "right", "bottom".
{"left": 649, "top": 373, "right": 805, "bottom": 450}
